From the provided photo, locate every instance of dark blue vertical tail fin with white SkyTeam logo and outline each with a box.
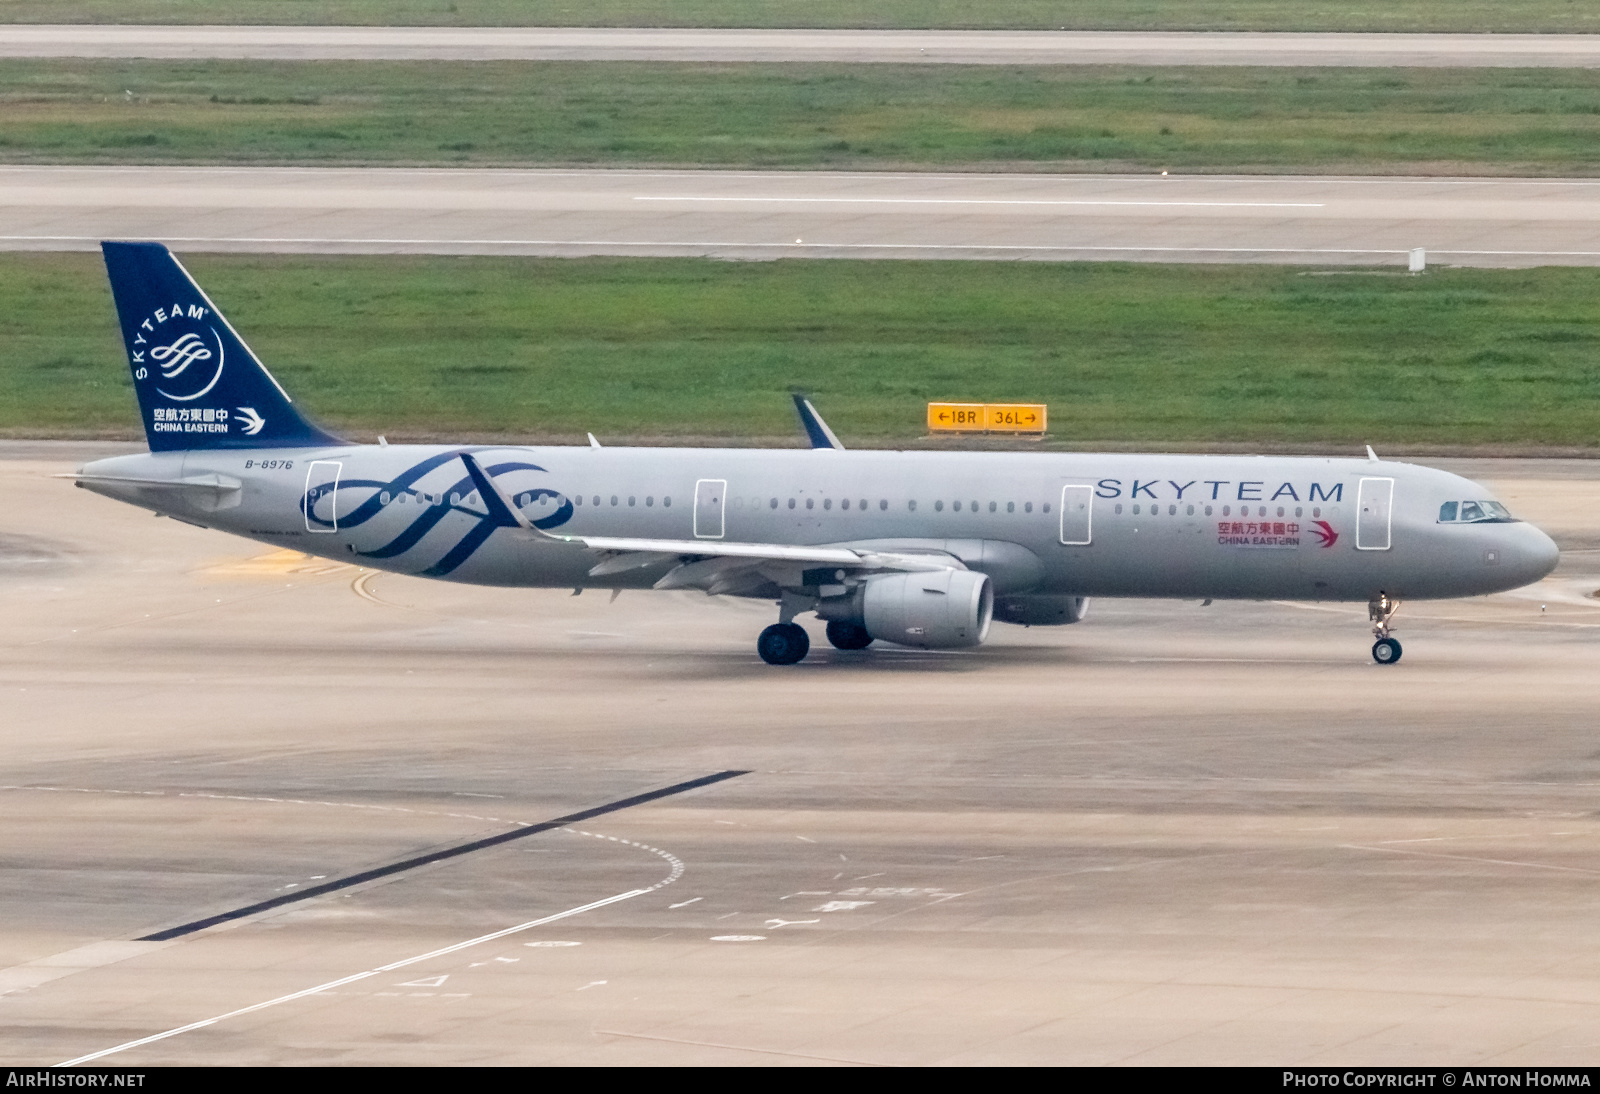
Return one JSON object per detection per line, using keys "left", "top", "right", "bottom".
{"left": 101, "top": 243, "right": 341, "bottom": 453}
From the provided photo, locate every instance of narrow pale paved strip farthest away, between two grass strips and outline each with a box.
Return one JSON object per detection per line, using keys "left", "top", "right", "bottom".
{"left": 9, "top": 24, "right": 1600, "bottom": 69}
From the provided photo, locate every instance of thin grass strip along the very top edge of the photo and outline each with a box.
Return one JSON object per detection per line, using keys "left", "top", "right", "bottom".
{"left": 0, "top": 0, "right": 1600, "bottom": 32}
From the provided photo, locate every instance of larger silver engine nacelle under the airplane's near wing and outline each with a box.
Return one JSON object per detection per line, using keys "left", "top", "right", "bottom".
{"left": 861, "top": 569, "right": 995, "bottom": 649}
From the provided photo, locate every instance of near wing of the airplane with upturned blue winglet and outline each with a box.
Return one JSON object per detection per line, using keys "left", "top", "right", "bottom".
{"left": 461, "top": 453, "right": 966, "bottom": 592}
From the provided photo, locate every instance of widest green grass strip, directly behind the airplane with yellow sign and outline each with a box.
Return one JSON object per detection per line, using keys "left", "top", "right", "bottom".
{"left": 0, "top": 253, "right": 1600, "bottom": 451}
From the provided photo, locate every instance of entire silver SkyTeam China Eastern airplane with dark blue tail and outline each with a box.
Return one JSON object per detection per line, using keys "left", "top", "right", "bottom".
{"left": 74, "top": 242, "right": 1558, "bottom": 665}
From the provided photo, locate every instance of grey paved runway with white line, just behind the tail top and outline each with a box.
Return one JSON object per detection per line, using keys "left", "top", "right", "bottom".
{"left": 9, "top": 166, "right": 1600, "bottom": 267}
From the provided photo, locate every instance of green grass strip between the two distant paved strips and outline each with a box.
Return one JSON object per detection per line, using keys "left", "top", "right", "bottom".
{"left": 9, "top": 61, "right": 1600, "bottom": 174}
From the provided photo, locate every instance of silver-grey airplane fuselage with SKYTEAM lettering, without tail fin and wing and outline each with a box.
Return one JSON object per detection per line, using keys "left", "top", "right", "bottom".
{"left": 82, "top": 445, "right": 1557, "bottom": 601}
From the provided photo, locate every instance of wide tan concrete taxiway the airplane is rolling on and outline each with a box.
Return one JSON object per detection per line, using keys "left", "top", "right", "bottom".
{"left": 0, "top": 443, "right": 1600, "bottom": 1067}
